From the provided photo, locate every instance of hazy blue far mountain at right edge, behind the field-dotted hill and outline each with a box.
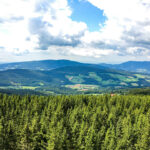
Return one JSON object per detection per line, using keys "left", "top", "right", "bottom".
{"left": 100, "top": 61, "right": 150, "bottom": 73}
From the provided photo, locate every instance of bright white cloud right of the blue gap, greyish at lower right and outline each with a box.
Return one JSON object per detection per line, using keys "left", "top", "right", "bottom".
{"left": 84, "top": 0, "right": 150, "bottom": 55}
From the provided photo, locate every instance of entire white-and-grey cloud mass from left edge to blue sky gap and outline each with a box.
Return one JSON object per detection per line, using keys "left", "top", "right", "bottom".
{"left": 0, "top": 0, "right": 87, "bottom": 54}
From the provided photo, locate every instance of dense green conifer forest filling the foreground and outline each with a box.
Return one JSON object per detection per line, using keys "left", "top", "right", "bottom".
{"left": 0, "top": 94, "right": 150, "bottom": 150}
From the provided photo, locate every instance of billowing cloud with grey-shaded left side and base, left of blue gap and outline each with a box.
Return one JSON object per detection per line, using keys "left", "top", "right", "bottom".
{"left": 29, "top": 0, "right": 87, "bottom": 50}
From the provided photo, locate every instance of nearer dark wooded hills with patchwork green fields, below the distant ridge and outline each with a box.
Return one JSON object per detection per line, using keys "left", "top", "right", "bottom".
{"left": 0, "top": 66, "right": 150, "bottom": 91}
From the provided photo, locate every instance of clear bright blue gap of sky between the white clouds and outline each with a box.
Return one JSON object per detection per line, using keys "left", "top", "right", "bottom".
{"left": 68, "top": 0, "right": 106, "bottom": 32}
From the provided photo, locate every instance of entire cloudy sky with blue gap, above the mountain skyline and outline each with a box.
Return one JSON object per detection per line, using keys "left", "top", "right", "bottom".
{"left": 0, "top": 0, "right": 150, "bottom": 63}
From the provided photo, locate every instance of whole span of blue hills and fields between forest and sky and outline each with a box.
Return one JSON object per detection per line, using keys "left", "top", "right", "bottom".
{"left": 0, "top": 60, "right": 150, "bottom": 92}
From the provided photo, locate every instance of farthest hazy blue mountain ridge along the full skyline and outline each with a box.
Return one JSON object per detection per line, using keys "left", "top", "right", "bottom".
{"left": 0, "top": 60, "right": 150, "bottom": 73}
